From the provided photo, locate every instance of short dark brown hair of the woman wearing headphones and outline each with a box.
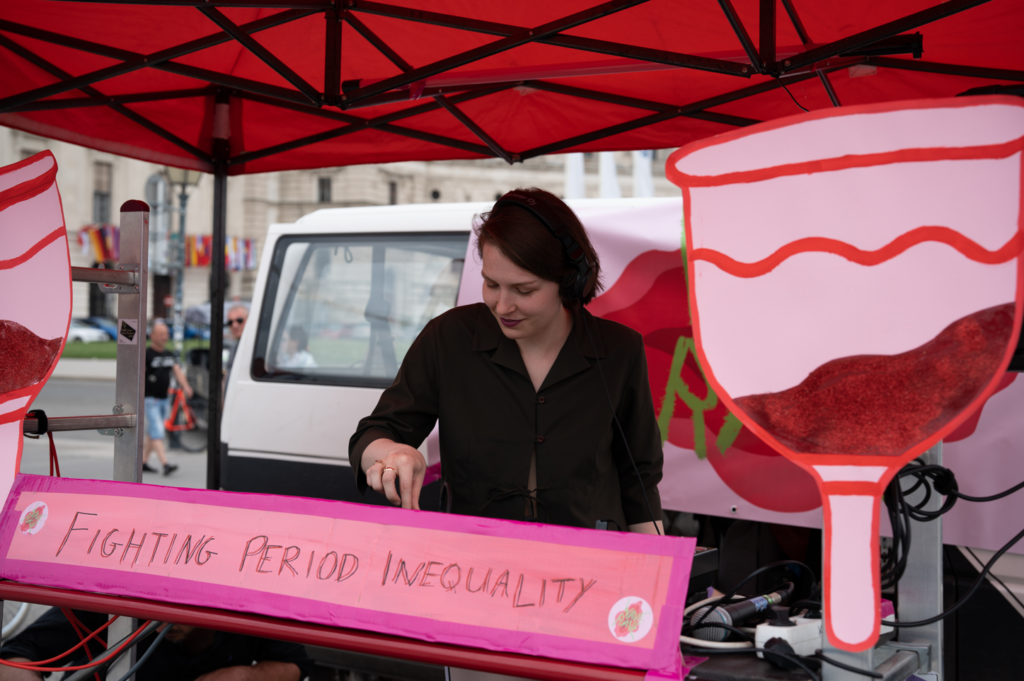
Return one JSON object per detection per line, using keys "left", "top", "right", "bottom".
{"left": 473, "top": 187, "right": 602, "bottom": 307}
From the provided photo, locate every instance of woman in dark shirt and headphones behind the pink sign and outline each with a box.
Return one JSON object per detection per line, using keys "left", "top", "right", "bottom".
{"left": 349, "top": 188, "right": 663, "bottom": 534}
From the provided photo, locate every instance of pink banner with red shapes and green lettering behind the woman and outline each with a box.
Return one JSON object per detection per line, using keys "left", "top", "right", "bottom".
{"left": 462, "top": 196, "right": 1024, "bottom": 553}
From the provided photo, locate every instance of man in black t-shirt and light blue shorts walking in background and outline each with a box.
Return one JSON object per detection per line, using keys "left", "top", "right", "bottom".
{"left": 142, "top": 322, "right": 191, "bottom": 475}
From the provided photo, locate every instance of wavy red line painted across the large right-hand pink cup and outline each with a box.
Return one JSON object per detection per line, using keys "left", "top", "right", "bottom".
{"left": 690, "top": 226, "right": 1024, "bottom": 279}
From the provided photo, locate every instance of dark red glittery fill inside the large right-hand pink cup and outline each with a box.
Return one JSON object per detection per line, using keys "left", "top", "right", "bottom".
{"left": 735, "top": 303, "right": 1015, "bottom": 456}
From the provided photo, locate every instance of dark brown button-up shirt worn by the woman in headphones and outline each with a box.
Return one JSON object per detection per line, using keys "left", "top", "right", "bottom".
{"left": 349, "top": 303, "right": 663, "bottom": 529}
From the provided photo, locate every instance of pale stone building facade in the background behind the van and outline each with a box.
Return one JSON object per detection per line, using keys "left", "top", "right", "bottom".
{"left": 0, "top": 127, "right": 678, "bottom": 318}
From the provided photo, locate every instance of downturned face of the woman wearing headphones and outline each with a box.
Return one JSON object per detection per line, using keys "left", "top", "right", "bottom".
{"left": 482, "top": 243, "right": 563, "bottom": 340}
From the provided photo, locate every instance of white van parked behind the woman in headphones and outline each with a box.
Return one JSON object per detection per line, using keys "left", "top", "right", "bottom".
{"left": 221, "top": 198, "right": 682, "bottom": 503}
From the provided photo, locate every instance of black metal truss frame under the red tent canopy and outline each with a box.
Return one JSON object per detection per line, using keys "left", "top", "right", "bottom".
{"left": 0, "top": 0, "right": 1024, "bottom": 169}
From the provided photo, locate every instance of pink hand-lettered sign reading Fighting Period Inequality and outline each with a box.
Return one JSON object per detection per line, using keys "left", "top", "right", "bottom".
{"left": 0, "top": 475, "right": 694, "bottom": 678}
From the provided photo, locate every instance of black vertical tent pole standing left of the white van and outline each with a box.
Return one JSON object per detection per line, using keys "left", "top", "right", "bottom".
{"left": 206, "top": 90, "right": 230, "bottom": 490}
